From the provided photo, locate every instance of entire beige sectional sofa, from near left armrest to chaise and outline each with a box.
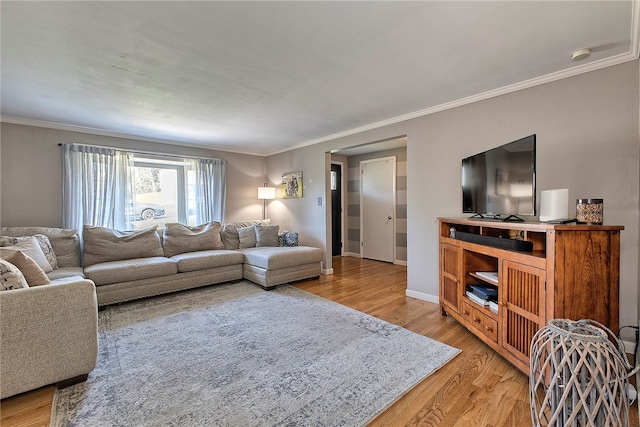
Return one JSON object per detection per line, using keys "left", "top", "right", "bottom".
{"left": 0, "top": 220, "right": 322, "bottom": 398}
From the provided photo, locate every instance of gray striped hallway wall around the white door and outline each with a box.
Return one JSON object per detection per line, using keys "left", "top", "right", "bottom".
{"left": 347, "top": 148, "right": 407, "bottom": 263}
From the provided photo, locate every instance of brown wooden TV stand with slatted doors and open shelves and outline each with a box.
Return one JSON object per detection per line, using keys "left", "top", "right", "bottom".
{"left": 438, "top": 218, "right": 624, "bottom": 375}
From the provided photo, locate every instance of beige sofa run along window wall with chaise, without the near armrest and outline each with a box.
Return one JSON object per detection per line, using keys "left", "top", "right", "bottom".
{"left": 0, "top": 220, "right": 322, "bottom": 306}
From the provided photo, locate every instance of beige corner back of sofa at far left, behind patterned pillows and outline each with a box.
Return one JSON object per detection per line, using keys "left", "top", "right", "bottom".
{"left": 0, "top": 227, "right": 80, "bottom": 268}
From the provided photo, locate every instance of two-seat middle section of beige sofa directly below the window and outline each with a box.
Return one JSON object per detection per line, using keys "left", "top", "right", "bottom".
{"left": 83, "top": 224, "right": 248, "bottom": 306}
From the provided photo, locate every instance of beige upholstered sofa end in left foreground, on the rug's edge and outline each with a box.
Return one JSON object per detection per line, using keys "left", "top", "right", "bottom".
{"left": 0, "top": 279, "right": 98, "bottom": 399}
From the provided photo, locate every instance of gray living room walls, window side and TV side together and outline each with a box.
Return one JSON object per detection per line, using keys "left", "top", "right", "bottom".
{"left": 0, "top": 60, "right": 640, "bottom": 338}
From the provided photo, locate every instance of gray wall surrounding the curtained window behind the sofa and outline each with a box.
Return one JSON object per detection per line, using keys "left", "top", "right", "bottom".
{"left": 0, "top": 123, "right": 265, "bottom": 227}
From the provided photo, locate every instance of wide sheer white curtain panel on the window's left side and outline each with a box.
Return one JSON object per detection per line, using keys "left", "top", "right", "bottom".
{"left": 62, "top": 144, "right": 133, "bottom": 233}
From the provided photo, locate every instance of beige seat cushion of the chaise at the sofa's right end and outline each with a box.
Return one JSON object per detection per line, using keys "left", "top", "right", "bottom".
{"left": 241, "top": 246, "right": 322, "bottom": 270}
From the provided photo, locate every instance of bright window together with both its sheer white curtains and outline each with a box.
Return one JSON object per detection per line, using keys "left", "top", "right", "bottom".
{"left": 63, "top": 144, "right": 226, "bottom": 231}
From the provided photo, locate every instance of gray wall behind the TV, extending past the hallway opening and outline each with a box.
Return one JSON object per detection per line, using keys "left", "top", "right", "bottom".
{"left": 267, "top": 60, "right": 640, "bottom": 334}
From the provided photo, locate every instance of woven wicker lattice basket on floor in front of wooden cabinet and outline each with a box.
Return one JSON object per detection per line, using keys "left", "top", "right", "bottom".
{"left": 529, "top": 319, "right": 631, "bottom": 427}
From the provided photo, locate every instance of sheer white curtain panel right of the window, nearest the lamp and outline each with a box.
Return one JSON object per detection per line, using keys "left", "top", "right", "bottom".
{"left": 192, "top": 158, "right": 227, "bottom": 224}
